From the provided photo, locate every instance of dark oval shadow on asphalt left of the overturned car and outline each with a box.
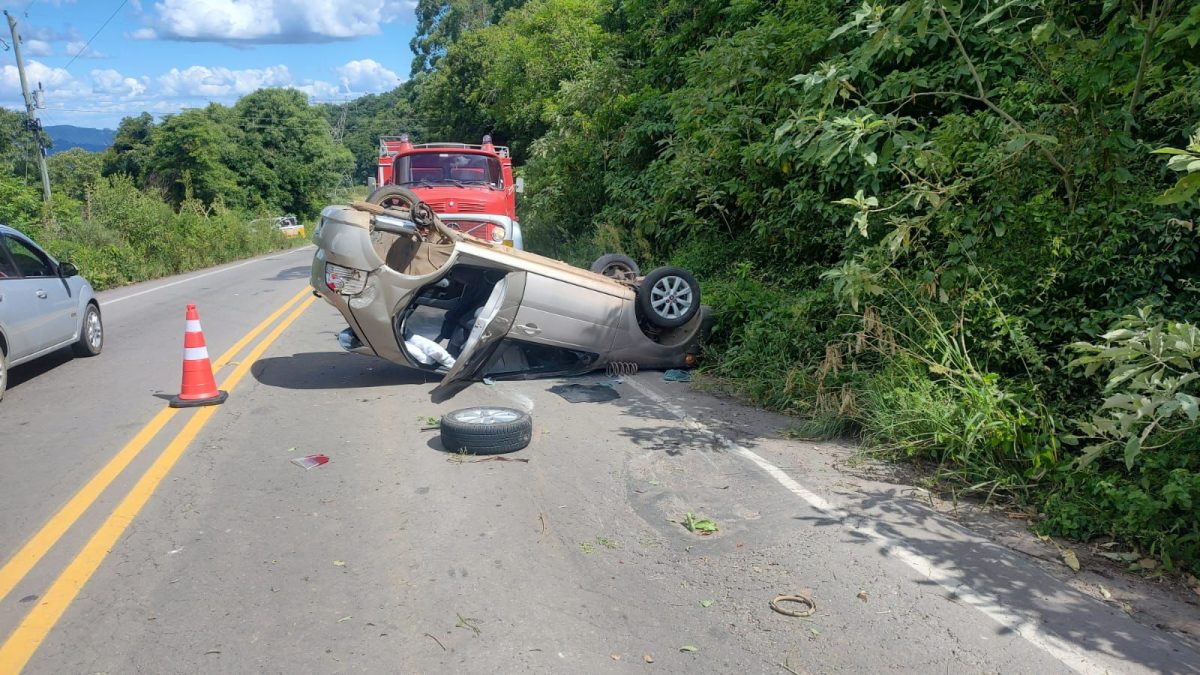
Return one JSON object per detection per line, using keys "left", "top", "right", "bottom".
{"left": 250, "top": 352, "right": 438, "bottom": 389}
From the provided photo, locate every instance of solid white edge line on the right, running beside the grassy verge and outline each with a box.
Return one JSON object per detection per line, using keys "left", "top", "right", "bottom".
{"left": 625, "top": 377, "right": 1109, "bottom": 674}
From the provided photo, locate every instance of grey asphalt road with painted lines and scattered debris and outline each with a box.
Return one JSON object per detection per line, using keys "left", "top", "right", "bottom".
{"left": 0, "top": 249, "right": 1200, "bottom": 674}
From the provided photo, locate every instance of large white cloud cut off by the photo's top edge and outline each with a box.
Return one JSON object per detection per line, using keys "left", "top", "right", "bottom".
{"left": 143, "top": 0, "right": 412, "bottom": 43}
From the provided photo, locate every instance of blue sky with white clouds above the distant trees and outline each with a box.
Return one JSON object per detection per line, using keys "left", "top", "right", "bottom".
{"left": 0, "top": 0, "right": 416, "bottom": 129}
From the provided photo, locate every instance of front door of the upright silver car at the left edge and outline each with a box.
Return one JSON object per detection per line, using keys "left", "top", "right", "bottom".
{"left": 0, "top": 235, "right": 78, "bottom": 360}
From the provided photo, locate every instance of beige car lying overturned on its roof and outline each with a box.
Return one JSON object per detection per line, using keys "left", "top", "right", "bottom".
{"left": 311, "top": 190, "right": 708, "bottom": 401}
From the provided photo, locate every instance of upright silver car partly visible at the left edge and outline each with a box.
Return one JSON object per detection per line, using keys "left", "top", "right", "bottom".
{"left": 0, "top": 225, "right": 104, "bottom": 399}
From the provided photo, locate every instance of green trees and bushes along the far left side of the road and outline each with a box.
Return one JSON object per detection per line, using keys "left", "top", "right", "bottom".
{"left": 0, "top": 89, "right": 353, "bottom": 288}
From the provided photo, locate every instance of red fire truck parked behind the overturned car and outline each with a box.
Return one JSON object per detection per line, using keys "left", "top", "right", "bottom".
{"left": 376, "top": 136, "right": 524, "bottom": 249}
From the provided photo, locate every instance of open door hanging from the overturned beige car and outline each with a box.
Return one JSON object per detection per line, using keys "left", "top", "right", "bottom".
{"left": 430, "top": 271, "right": 526, "bottom": 404}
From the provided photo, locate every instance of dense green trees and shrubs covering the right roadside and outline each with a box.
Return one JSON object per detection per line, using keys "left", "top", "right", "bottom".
{"left": 364, "top": 0, "right": 1200, "bottom": 566}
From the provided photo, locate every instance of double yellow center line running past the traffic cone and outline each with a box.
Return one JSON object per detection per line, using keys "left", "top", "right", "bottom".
{"left": 0, "top": 282, "right": 316, "bottom": 673}
